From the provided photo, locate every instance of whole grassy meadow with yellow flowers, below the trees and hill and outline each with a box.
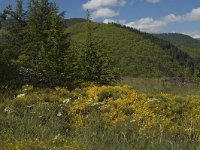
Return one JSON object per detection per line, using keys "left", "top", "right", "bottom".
{"left": 0, "top": 81, "right": 200, "bottom": 150}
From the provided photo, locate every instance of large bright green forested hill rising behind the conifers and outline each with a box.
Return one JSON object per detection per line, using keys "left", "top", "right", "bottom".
{"left": 66, "top": 23, "right": 194, "bottom": 77}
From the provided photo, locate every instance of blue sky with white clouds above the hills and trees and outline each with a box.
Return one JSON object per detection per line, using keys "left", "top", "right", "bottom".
{"left": 0, "top": 0, "right": 200, "bottom": 38}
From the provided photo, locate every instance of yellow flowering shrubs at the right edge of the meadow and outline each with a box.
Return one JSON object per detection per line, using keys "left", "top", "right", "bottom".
{"left": 146, "top": 93, "right": 200, "bottom": 131}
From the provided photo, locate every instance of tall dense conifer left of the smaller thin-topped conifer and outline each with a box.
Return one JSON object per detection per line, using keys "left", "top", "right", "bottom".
{"left": 18, "top": 0, "right": 69, "bottom": 86}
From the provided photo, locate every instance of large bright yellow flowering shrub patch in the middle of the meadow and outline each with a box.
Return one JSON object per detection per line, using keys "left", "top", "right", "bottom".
{"left": 70, "top": 86, "right": 176, "bottom": 131}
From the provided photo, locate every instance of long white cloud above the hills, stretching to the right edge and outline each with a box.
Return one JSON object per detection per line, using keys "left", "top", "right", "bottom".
{"left": 126, "top": 8, "right": 200, "bottom": 32}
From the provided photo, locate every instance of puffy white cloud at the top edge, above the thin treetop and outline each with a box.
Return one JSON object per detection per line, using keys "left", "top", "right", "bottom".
{"left": 82, "top": 0, "right": 126, "bottom": 10}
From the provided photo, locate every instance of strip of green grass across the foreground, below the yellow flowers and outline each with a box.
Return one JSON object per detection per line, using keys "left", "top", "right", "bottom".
{"left": 0, "top": 106, "right": 198, "bottom": 150}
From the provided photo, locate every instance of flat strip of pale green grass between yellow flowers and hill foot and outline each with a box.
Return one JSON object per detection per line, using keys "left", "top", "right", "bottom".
{"left": 120, "top": 77, "right": 200, "bottom": 96}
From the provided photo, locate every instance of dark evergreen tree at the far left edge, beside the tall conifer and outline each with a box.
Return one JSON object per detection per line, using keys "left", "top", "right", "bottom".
{"left": 0, "top": 0, "right": 25, "bottom": 86}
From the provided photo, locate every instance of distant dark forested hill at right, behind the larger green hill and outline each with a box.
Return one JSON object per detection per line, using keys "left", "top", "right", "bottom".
{"left": 155, "top": 33, "right": 200, "bottom": 48}
